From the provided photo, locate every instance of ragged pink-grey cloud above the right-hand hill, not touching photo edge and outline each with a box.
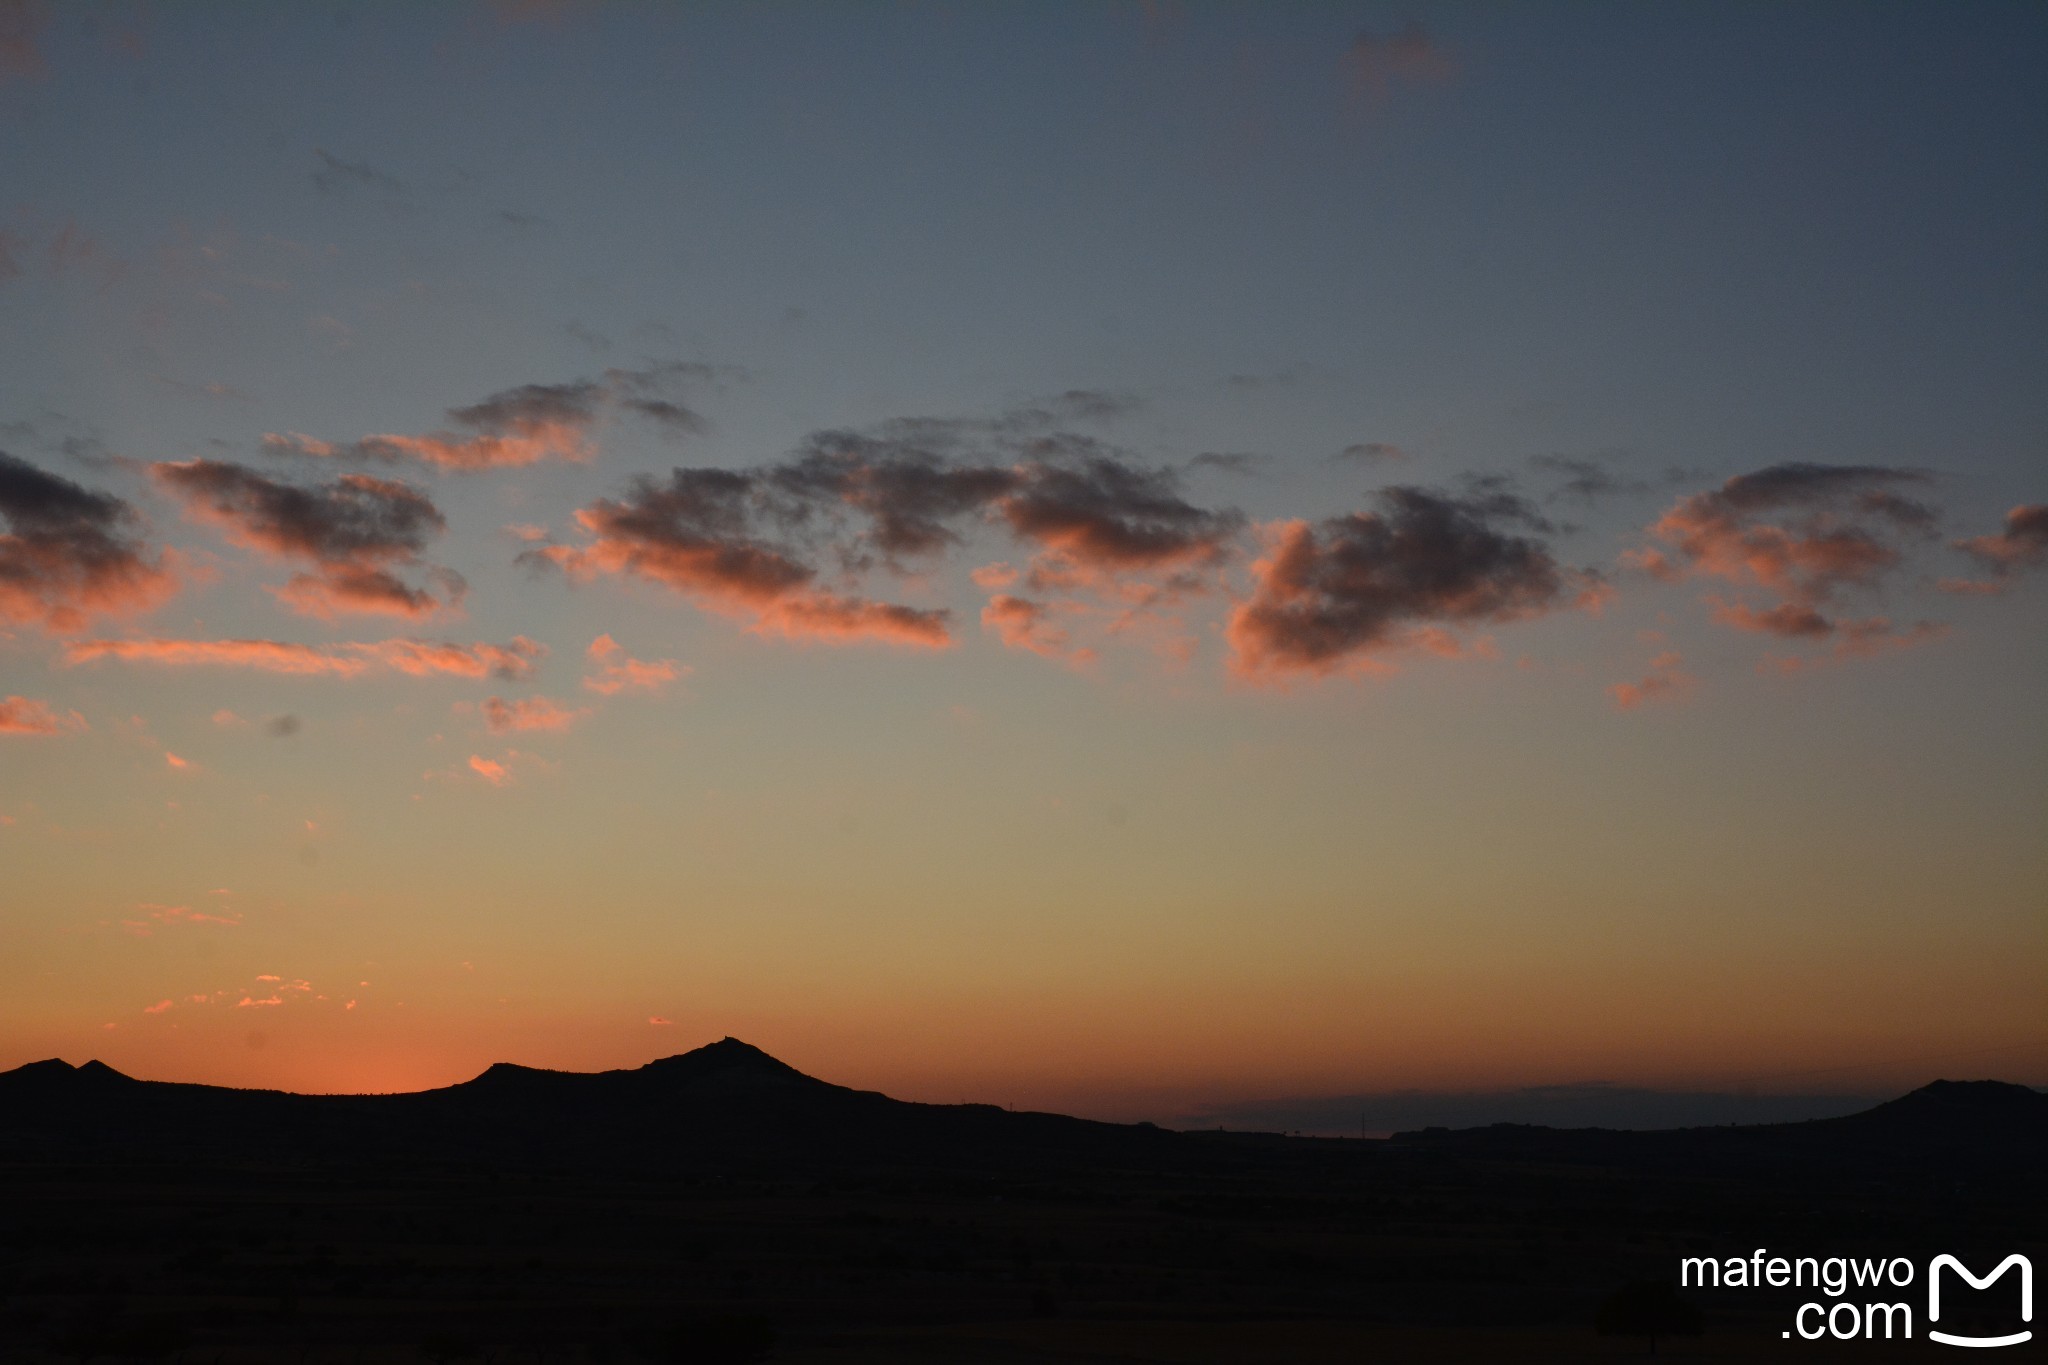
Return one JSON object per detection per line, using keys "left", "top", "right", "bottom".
{"left": 1624, "top": 465, "right": 1937, "bottom": 639}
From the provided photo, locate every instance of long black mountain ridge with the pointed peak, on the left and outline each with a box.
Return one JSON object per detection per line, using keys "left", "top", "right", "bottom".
{"left": 0, "top": 1038, "right": 1198, "bottom": 1171}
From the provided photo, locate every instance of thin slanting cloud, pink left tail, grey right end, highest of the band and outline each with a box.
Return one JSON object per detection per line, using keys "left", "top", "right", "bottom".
{"left": 262, "top": 362, "right": 725, "bottom": 473}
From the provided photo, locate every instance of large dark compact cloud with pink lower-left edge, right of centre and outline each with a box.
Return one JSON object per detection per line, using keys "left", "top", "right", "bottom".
{"left": 1229, "top": 487, "right": 1595, "bottom": 679}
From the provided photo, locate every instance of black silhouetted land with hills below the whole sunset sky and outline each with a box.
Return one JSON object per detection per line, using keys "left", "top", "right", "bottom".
{"left": 0, "top": 1040, "right": 2048, "bottom": 1365}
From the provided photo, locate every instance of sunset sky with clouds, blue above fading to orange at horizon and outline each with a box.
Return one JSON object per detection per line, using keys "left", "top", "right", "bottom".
{"left": 0, "top": 0, "right": 2048, "bottom": 1128}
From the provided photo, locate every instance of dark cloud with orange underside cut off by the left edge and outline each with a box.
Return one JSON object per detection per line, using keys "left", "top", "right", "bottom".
{"left": 0, "top": 450, "right": 178, "bottom": 634}
